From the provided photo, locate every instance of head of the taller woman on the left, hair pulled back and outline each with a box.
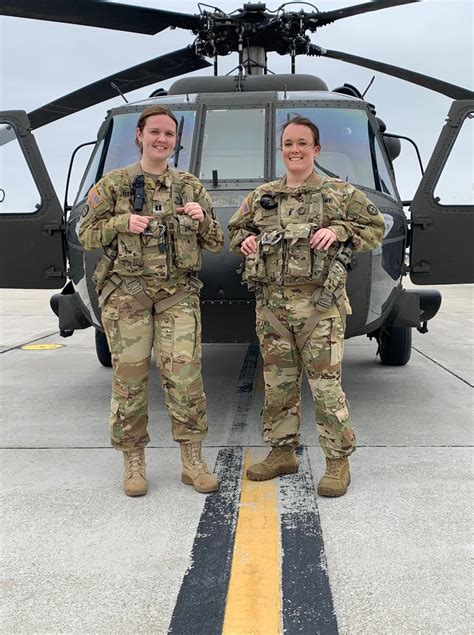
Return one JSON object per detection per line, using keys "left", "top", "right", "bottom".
{"left": 135, "top": 106, "right": 178, "bottom": 162}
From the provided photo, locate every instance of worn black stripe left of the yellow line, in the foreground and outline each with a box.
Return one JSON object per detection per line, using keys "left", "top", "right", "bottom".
{"left": 168, "top": 448, "right": 243, "bottom": 635}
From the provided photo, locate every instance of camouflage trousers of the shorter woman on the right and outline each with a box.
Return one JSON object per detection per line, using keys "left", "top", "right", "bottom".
{"left": 257, "top": 287, "right": 355, "bottom": 458}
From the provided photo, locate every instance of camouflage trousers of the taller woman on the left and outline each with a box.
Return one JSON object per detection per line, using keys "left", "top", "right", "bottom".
{"left": 102, "top": 280, "right": 207, "bottom": 451}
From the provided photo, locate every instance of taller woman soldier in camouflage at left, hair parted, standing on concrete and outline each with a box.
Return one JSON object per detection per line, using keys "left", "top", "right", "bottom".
{"left": 79, "top": 106, "right": 224, "bottom": 496}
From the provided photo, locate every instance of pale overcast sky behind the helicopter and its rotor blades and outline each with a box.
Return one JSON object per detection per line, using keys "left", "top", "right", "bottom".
{"left": 0, "top": 0, "right": 474, "bottom": 200}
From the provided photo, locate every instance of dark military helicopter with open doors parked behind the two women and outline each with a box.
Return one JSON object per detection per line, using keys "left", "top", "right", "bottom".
{"left": 0, "top": 0, "right": 474, "bottom": 365}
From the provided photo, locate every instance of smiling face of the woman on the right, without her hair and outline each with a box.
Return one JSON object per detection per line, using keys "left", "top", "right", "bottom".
{"left": 281, "top": 123, "right": 320, "bottom": 174}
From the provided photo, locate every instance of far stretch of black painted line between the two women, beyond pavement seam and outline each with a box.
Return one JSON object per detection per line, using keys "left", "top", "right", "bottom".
{"left": 227, "top": 344, "right": 260, "bottom": 445}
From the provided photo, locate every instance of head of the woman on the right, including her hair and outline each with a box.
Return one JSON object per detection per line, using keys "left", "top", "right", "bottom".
{"left": 281, "top": 115, "right": 321, "bottom": 176}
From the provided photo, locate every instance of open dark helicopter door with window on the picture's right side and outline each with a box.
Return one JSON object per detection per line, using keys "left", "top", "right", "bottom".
{"left": 410, "top": 100, "right": 474, "bottom": 284}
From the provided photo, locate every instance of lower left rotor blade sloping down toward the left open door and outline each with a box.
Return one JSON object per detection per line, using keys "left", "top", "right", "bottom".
{"left": 28, "top": 46, "right": 211, "bottom": 129}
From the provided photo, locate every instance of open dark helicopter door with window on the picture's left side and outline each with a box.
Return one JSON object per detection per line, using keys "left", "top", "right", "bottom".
{"left": 0, "top": 110, "right": 66, "bottom": 289}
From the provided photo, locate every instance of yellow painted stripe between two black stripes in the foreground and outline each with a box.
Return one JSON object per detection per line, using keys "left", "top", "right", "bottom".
{"left": 222, "top": 450, "right": 281, "bottom": 635}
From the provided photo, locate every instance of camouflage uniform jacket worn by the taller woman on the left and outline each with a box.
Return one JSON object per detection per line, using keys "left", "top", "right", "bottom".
{"left": 79, "top": 164, "right": 224, "bottom": 287}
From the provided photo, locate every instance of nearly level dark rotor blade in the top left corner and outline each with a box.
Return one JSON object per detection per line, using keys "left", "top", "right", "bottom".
{"left": 0, "top": 0, "right": 200, "bottom": 35}
